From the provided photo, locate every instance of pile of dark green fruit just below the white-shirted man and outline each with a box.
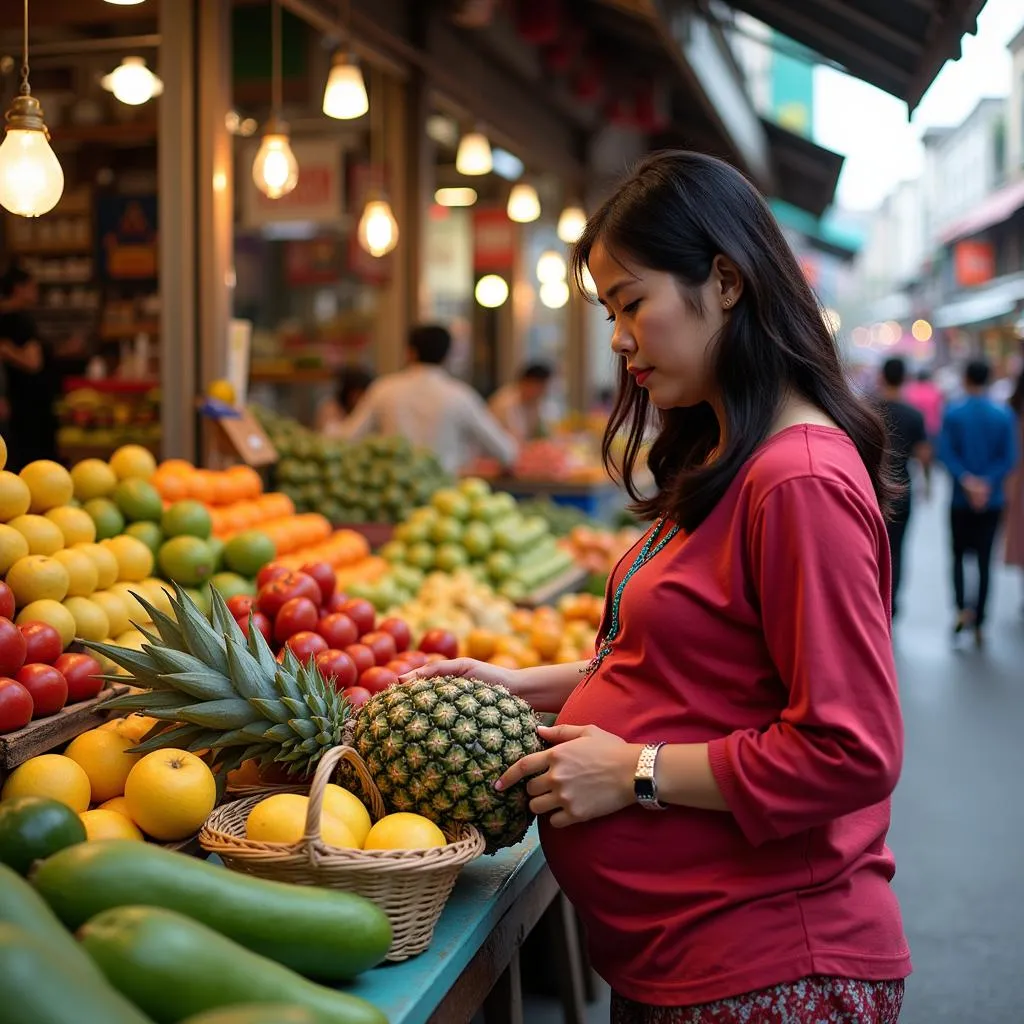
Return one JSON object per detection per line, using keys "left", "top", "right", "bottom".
{"left": 253, "top": 407, "right": 451, "bottom": 523}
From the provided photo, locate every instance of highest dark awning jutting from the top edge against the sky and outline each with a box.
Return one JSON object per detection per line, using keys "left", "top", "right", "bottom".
{"left": 729, "top": 0, "right": 985, "bottom": 111}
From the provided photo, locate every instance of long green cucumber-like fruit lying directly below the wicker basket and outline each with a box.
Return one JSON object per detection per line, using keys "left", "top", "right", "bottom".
{"left": 31, "top": 840, "right": 391, "bottom": 981}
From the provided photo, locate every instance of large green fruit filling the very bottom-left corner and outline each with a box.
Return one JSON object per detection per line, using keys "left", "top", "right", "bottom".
{"left": 0, "top": 924, "right": 152, "bottom": 1024}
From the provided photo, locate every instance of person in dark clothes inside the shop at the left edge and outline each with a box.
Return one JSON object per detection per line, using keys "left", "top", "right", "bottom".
{"left": 0, "top": 266, "right": 59, "bottom": 472}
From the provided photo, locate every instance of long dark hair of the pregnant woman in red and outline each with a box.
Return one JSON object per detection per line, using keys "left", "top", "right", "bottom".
{"left": 572, "top": 151, "right": 894, "bottom": 531}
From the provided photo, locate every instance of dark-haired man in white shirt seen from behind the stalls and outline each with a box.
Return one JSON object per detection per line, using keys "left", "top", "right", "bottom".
{"left": 328, "top": 325, "right": 517, "bottom": 474}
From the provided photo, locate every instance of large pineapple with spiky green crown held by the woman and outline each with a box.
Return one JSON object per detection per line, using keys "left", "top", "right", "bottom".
{"left": 86, "top": 586, "right": 542, "bottom": 853}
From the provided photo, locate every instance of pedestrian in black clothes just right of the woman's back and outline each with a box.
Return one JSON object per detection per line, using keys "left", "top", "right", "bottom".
{"left": 880, "top": 356, "right": 932, "bottom": 617}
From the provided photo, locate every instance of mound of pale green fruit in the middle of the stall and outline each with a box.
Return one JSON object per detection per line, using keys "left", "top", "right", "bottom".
{"left": 381, "top": 478, "right": 572, "bottom": 601}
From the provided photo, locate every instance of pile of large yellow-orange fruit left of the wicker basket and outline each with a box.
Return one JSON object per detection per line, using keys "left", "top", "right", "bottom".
{"left": 0, "top": 715, "right": 217, "bottom": 842}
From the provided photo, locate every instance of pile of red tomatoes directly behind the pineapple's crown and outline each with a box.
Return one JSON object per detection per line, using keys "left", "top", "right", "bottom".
{"left": 227, "top": 562, "right": 459, "bottom": 707}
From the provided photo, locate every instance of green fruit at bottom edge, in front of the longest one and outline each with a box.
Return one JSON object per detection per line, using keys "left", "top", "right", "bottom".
{"left": 78, "top": 906, "right": 387, "bottom": 1024}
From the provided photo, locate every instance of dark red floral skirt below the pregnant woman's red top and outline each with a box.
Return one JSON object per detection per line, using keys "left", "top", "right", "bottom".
{"left": 611, "top": 977, "right": 903, "bottom": 1024}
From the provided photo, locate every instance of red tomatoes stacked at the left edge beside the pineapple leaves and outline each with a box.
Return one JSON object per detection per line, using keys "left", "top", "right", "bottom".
{"left": 0, "top": 583, "right": 103, "bottom": 732}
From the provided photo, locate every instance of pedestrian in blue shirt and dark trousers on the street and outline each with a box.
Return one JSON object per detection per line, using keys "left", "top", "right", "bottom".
{"left": 939, "top": 359, "right": 1018, "bottom": 646}
